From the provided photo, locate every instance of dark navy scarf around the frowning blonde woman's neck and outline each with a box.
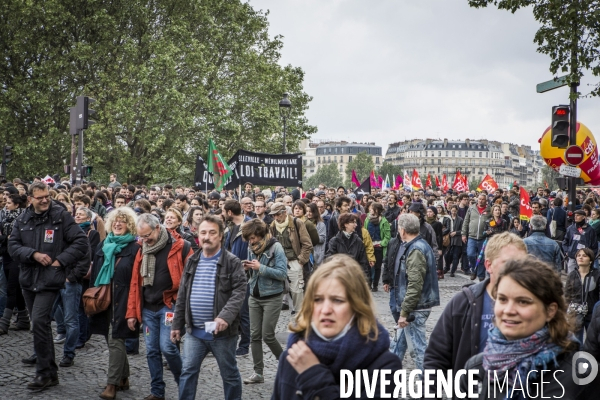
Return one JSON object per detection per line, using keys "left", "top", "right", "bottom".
{"left": 287, "top": 322, "right": 390, "bottom": 379}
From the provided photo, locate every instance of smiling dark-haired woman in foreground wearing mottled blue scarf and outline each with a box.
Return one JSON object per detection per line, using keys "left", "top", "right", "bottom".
{"left": 461, "top": 256, "right": 588, "bottom": 400}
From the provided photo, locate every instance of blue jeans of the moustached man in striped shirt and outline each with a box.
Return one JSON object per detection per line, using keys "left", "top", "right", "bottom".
{"left": 179, "top": 333, "right": 242, "bottom": 400}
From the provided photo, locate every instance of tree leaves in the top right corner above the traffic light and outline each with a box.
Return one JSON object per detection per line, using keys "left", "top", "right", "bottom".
{"left": 468, "top": 0, "right": 600, "bottom": 97}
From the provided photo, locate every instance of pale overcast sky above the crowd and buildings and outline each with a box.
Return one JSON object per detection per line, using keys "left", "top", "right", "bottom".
{"left": 249, "top": 0, "right": 600, "bottom": 154}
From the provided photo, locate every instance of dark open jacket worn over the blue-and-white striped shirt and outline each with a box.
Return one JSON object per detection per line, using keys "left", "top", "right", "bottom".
{"left": 171, "top": 248, "right": 247, "bottom": 338}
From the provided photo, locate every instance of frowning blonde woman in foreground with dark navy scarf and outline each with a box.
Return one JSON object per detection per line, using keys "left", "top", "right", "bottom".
{"left": 271, "top": 255, "right": 402, "bottom": 400}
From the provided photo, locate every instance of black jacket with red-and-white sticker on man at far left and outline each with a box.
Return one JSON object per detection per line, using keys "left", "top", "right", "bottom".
{"left": 8, "top": 201, "right": 91, "bottom": 292}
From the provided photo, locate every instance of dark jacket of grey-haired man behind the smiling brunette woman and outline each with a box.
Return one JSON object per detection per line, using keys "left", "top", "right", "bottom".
{"left": 424, "top": 278, "right": 490, "bottom": 371}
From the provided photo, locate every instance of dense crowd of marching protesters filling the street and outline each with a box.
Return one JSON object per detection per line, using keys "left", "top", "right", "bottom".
{"left": 0, "top": 174, "right": 600, "bottom": 400}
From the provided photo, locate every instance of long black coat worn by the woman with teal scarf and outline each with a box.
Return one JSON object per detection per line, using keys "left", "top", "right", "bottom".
{"left": 90, "top": 241, "right": 141, "bottom": 339}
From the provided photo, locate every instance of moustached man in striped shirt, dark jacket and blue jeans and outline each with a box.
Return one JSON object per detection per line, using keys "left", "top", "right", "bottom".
{"left": 171, "top": 215, "right": 246, "bottom": 400}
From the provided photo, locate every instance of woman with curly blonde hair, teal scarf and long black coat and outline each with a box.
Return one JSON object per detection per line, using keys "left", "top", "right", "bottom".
{"left": 90, "top": 207, "right": 140, "bottom": 399}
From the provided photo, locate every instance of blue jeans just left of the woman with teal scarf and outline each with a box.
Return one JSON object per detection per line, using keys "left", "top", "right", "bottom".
{"left": 54, "top": 282, "right": 81, "bottom": 358}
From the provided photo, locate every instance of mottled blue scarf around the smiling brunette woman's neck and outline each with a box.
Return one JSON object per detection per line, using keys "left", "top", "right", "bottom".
{"left": 483, "top": 326, "right": 563, "bottom": 386}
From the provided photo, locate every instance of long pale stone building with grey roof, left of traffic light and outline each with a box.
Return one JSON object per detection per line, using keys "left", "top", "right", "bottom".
{"left": 385, "top": 139, "right": 544, "bottom": 187}
